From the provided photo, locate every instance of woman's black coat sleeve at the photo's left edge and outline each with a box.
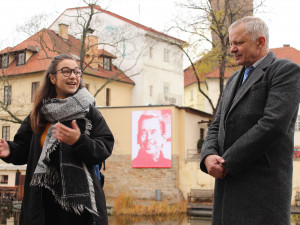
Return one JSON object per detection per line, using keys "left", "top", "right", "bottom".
{"left": 3, "top": 116, "right": 33, "bottom": 165}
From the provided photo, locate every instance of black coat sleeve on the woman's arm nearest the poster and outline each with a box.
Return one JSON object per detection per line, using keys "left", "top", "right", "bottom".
{"left": 72, "top": 106, "right": 114, "bottom": 165}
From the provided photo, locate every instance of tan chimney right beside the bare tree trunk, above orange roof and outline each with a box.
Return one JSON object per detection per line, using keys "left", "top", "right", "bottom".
{"left": 85, "top": 35, "right": 99, "bottom": 69}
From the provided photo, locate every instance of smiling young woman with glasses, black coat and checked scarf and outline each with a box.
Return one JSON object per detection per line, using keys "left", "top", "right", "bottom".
{"left": 0, "top": 55, "right": 114, "bottom": 225}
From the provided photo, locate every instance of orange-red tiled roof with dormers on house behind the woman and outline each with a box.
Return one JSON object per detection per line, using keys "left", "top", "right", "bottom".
{"left": 0, "top": 29, "right": 134, "bottom": 84}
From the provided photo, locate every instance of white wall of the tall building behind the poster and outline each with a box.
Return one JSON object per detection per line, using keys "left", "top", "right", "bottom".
{"left": 50, "top": 9, "right": 184, "bottom": 106}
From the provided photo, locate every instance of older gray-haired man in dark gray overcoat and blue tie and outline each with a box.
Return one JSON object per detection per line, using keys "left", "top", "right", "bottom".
{"left": 200, "top": 17, "right": 300, "bottom": 225}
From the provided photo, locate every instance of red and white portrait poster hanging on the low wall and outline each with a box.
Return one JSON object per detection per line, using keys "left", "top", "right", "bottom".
{"left": 132, "top": 109, "right": 172, "bottom": 168}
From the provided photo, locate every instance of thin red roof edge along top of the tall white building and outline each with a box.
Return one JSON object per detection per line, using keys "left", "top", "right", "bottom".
{"left": 49, "top": 6, "right": 186, "bottom": 45}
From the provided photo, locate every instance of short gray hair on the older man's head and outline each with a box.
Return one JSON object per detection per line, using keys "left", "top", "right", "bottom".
{"left": 228, "top": 16, "right": 269, "bottom": 48}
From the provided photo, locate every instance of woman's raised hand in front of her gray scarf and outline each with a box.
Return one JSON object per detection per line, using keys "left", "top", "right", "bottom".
{"left": 52, "top": 120, "right": 81, "bottom": 145}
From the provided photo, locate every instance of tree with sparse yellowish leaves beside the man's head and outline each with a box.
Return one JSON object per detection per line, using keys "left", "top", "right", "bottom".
{"left": 171, "top": 0, "right": 264, "bottom": 118}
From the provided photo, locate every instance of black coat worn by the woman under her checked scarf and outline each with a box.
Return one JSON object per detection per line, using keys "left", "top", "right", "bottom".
{"left": 3, "top": 105, "right": 114, "bottom": 225}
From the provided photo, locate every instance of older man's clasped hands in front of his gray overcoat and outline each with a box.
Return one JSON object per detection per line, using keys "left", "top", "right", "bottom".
{"left": 204, "top": 155, "right": 228, "bottom": 179}
